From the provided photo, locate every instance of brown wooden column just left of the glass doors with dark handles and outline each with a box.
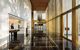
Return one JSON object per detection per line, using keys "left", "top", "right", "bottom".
{"left": 60, "top": 0, "right": 64, "bottom": 50}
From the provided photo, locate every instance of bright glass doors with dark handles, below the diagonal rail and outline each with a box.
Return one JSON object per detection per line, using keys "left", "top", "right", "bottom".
{"left": 63, "top": 12, "right": 72, "bottom": 40}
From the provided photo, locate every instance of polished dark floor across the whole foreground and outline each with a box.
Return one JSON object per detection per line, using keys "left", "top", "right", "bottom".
{"left": 4, "top": 34, "right": 72, "bottom": 50}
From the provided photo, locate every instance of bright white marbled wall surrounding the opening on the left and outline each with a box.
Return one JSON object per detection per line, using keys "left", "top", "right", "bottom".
{"left": 0, "top": 0, "right": 31, "bottom": 46}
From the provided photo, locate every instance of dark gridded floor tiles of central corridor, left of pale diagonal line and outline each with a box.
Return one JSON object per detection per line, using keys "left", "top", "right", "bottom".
{"left": 31, "top": 33, "right": 58, "bottom": 50}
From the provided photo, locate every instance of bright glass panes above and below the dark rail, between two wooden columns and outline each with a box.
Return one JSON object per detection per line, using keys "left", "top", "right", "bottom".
{"left": 63, "top": 0, "right": 72, "bottom": 40}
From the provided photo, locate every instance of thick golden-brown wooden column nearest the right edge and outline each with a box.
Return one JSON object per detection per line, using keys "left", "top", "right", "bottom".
{"left": 72, "top": 0, "right": 78, "bottom": 50}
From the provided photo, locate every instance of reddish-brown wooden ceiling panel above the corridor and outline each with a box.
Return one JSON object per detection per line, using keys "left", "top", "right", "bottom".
{"left": 30, "top": 0, "right": 49, "bottom": 11}
